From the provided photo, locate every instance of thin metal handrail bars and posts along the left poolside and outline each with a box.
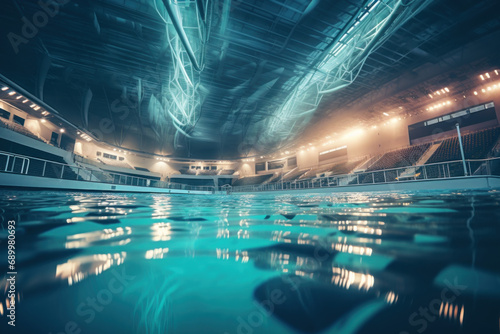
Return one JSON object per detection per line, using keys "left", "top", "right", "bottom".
{"left": 0, "top": 151, "right": 215, "bottom": 192}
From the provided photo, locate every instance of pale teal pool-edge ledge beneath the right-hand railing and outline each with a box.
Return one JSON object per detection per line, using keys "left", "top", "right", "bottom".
{"left": 233, "top": 175, "right": 500, "bottom": 195}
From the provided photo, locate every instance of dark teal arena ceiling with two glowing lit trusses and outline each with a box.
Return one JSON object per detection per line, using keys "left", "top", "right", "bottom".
{"left": 0, "top": 0, "right": 500, "bottom": 159}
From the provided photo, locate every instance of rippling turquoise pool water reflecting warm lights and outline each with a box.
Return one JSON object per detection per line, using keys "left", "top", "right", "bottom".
{"left": 0, "top": 191, "right": 500, "bottom": 334}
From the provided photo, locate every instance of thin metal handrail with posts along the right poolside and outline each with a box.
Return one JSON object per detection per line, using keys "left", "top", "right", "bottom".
{"left": 232, "top": 158, "right": 500, "bottom": 192}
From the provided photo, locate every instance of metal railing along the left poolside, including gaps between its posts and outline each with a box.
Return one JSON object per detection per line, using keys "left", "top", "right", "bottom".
{"left": 0, "top": 151, "right": 215, "bottom": 192}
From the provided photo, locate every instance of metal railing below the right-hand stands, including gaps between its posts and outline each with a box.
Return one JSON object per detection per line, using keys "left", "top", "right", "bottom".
{"left": 231, "top": 158, "right": 500, "bottom": 193}
